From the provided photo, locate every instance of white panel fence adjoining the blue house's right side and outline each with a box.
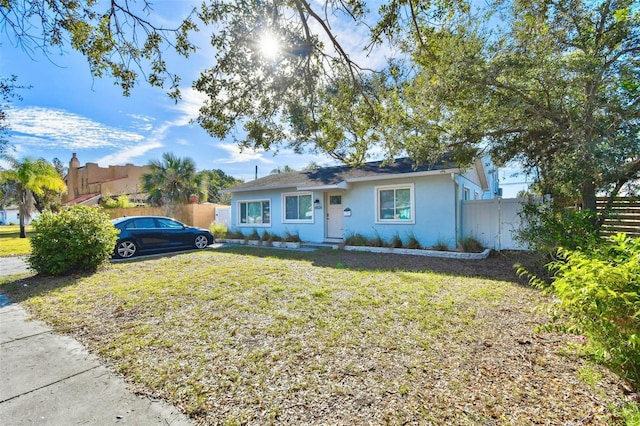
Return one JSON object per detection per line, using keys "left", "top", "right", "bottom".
{"left": 460, "top": 198, "right": 527, "bottom": 250}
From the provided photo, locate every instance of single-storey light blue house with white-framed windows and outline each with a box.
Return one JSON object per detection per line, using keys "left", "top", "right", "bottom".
{"left": 228, "top": 158, "right": 499, "bottom": 247}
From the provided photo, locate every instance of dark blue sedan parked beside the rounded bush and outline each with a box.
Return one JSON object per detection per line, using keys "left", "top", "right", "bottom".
{"left": 111, "top": 216, "right": 213, "bottom": 259}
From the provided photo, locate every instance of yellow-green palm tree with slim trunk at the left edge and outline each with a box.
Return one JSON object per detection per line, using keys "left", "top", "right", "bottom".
{"left": 0, "top": 155, "right": 66, "bottom": 238}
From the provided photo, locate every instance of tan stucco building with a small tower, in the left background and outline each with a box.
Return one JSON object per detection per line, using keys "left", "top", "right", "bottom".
{"left": 62, "top": 152, "right": 150, "bottom": 205}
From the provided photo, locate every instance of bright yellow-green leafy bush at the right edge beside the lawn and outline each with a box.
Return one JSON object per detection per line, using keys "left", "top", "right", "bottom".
{"left": 535, "top": 234, "right": 640, "bottom": 389}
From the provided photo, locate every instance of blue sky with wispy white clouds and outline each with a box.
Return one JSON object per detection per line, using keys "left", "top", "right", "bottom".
{"left": 0, "top": 0, "right": 526, "bottom": 198}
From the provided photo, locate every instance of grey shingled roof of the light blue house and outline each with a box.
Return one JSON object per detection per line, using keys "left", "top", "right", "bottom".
{"left": 227, "top": 157, "right": 459, "bottom": 193}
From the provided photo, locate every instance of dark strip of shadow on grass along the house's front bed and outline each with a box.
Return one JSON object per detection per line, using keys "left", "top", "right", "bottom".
{"left": 217, "top": 245, "right": 544, "bottom": 284}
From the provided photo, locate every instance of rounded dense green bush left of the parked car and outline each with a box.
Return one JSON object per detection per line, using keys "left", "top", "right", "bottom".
{"left": 27, "top": 206, "right": 119, "bottom": 275}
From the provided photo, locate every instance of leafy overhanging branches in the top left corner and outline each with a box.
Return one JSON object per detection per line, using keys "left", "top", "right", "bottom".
{"left": 0, "top": 0, "right": 197, "bottom": 99}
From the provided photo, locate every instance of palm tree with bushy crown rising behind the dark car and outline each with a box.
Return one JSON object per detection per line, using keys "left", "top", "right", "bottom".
{"left": 141, "top": 153, "right": 201, "bottom": 211}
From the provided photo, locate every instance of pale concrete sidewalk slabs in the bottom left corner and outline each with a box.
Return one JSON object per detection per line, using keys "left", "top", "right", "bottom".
{"left": 0, "top": 302, "right": 193, "bottom": 426}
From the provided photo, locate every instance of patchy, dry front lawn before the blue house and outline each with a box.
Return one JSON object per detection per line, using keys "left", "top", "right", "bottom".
{"left": 0, "top": 247, "right": 628, "bottom": 425}
